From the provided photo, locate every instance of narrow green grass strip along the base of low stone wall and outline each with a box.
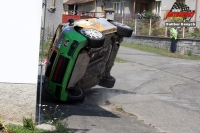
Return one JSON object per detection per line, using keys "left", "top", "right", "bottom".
{"left": 121, "top": 42, "right": 200, "bottom": 60}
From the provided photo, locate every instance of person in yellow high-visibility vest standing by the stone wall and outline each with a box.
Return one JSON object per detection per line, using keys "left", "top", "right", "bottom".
{"left": 170, "top": 27, "right": 178, "bottom": 53}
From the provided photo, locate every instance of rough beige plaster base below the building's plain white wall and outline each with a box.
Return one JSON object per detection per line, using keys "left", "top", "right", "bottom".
{"left": 0, "top": 83, "right": 37, "bottom": 122}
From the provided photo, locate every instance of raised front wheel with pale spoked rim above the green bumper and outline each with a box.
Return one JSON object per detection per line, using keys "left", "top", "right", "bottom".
{"left": 79, "top": 28, "right": 105, "bottom": 48}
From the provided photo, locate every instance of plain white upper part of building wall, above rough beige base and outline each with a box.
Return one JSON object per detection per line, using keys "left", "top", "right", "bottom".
{"left": 0, "top": 0, "right": 42, "bottom": 83}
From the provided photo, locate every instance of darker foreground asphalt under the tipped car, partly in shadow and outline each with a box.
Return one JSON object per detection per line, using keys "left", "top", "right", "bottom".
{"left": 38, "top": 87, "right": 160, "bottom": 133}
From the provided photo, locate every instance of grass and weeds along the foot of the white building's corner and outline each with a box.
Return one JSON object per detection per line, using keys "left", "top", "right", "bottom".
{"left": 0, "top": 105, "right": 69, "bottom": 133}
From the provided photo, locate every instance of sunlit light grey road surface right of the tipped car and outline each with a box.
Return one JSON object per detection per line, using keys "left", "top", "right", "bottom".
{"left": 109, "top": 47, "right": 200, "bottom": 133}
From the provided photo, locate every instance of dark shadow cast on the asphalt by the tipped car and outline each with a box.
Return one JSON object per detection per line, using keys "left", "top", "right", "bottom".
{"left": 37, "top": 84, "right": 135, "bottom": 122}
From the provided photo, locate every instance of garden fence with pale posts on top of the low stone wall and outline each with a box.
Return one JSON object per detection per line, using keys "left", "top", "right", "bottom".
{"left": 120, "top": 17, "right": 200, "bottom": 39}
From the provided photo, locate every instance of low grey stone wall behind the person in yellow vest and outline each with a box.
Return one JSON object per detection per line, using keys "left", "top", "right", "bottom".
{"left": 124, "top": 36, "right": 200, "bottom": 55}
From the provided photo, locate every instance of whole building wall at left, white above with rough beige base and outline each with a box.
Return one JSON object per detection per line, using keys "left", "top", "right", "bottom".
{"left": 0, "top": 0, "right": 42, "bottom": 122}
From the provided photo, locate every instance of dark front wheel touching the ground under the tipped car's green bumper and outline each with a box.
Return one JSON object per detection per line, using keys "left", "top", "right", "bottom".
{"left": 68, "top": 88, "right": 85, "bottom": 103}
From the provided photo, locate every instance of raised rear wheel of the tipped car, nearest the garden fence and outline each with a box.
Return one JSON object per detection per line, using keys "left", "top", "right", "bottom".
{"left": 110, "top": 21, "right": 133, "bottom": 37}
